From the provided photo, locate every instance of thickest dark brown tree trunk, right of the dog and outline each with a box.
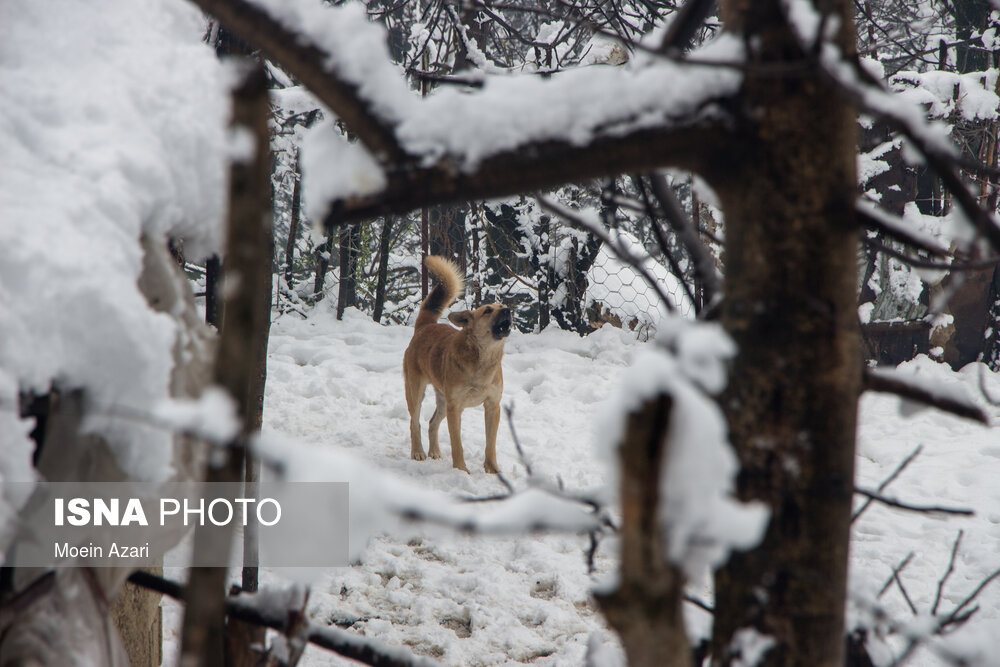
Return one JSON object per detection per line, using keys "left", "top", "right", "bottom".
{"left": 713, "top": 0, "right": 861, "bottom": 667}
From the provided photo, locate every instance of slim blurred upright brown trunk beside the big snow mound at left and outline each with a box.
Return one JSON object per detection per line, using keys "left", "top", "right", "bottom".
{"left": 181, "top": 67, "right": 274, "bottom": 667}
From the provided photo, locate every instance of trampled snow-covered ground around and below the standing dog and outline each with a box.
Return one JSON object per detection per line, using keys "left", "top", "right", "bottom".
{"left": 166, "top": 304, "right": 1000, "bottom": 666}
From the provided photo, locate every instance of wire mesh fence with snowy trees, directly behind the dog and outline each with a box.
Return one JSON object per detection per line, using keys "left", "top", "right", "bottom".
{"left": 275, "top": 194, "right": 693, "bottom": 340}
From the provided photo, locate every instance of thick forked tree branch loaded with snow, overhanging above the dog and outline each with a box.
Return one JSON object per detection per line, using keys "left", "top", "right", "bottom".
{"left": 189, "top": 0, "right": 742, "bottom": 228}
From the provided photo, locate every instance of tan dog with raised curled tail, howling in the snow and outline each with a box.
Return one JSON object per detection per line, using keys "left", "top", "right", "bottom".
{"left": 403, "top": 256, "right": 511, "bottom": 473}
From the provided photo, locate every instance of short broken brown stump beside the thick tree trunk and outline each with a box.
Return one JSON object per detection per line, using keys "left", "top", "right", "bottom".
{"left": 597, "top": 395, "right": 691, "bottom": 667}
